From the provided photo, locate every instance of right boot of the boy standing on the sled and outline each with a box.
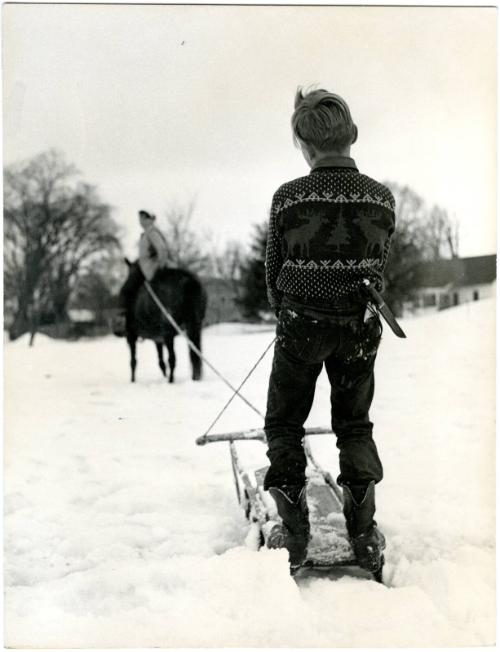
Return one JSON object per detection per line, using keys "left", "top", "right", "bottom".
{"left": 342, "top": 481, "right": 385, "bottom": 573}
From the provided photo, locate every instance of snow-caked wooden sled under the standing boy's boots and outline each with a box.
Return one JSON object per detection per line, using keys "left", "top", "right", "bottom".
{"left": 197, "top": 428, "right": 383, "bottom": 582}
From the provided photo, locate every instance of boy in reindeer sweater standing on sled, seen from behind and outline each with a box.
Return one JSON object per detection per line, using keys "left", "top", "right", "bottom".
{"left": 264, "top": 88, "right": 395, "bottom": 572}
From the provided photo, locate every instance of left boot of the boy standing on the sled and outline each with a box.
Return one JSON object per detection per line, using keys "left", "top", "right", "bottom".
{"left": 269, "top": 487, "right": 310, "bottom": 575}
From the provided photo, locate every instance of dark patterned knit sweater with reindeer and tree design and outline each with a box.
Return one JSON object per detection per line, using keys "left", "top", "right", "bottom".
{"left": 266, "top": 157, "right": 395, "bottom": 310}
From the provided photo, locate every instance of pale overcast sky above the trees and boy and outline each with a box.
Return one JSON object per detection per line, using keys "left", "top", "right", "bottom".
{"left": 3, "top": 4, "right": 497, "bottom": 256}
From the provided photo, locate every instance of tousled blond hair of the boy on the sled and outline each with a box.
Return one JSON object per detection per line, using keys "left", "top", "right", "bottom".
{"left": 292, "top": 86, "right": 358, "bottom": 152}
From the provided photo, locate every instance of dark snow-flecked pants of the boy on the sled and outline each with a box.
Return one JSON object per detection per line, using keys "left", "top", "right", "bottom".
{"left": 265, "top": 308, "right": 382, "bottom": 489}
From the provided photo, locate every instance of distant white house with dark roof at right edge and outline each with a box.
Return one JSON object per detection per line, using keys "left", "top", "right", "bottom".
{"left": 406, "top": 254, "right": 497, "bottom": 312}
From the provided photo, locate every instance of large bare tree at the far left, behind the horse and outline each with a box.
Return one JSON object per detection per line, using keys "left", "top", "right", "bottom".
{"left": 4, "top": 150, "right": 119, "bottom": 339}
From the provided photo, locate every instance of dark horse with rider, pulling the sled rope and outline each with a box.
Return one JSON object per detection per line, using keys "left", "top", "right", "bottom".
{"left": 113, "top": 259, "right": 207, "bottom": 383}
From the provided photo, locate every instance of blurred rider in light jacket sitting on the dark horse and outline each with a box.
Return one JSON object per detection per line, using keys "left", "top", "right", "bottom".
{"left": 119, "top": 210, "right": 168, "bottom": 324}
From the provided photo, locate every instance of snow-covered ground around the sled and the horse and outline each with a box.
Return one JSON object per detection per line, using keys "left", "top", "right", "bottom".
{"left": 4, "top": 301, "right": 495, "bottom": 648}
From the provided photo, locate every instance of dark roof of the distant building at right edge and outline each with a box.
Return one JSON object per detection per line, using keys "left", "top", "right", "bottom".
{"left": 417, "top": 254, "right": 497, "bottom": 287}
